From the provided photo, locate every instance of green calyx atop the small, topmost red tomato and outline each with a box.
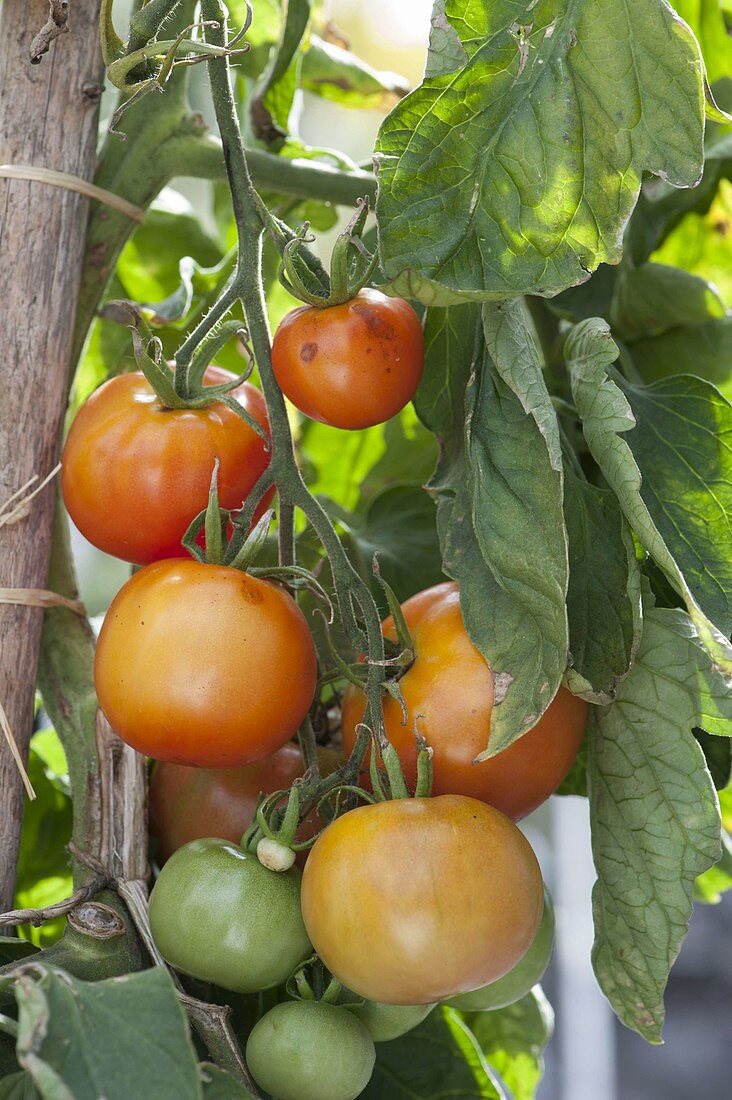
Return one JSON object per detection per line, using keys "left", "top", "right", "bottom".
{"left": 274, "top": 198, "right": 378, "bottom": 309}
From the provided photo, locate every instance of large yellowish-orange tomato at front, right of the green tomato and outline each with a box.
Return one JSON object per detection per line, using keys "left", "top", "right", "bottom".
{"left": 301, "top": 794, "right": 544, "bottom": 1004}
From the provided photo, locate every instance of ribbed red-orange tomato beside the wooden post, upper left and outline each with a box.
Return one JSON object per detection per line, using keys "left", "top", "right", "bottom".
{"left": 62, "top": 366, "right": 272, "bottom": 565}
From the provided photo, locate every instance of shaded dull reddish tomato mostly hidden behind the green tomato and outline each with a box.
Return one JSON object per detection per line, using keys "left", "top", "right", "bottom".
{"left": 150, "top": 741, "right": 343, "bottom": 867}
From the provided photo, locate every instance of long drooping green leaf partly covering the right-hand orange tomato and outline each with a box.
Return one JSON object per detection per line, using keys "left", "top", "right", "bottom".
{"left": 422, "top": 305, "right": 568, "bottom": 755}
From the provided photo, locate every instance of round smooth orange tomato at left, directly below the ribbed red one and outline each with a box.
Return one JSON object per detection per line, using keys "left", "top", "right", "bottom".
{"left": 94, "top": 559, "right": 317, "bottom": 768}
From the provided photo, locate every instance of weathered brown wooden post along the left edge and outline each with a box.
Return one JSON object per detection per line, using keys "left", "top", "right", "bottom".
{"left": 0, "top": 0, "right": 103, "bottom": 911}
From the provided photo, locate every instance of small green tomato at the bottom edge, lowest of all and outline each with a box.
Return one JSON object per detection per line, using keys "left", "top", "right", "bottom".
{"left": 247, "top": 1001, "right": 376, "bottom": 1100}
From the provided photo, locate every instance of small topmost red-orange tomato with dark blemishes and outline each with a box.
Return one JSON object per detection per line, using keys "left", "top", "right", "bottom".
{"left": 272, "top": 289, "right": 425, "bottom": 428}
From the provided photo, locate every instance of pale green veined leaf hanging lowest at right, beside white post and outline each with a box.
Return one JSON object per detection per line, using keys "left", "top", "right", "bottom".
{"left": 589, "top": 608, "right": 732, "bottom": 1043}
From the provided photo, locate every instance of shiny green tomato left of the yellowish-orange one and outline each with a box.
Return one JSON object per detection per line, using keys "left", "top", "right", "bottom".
{"left": 150, "top": 839, "right": 313, "bottom": 993}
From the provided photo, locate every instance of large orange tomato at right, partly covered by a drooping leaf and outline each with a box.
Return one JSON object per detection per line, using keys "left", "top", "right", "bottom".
{"left": 342, "top": 583, "right": 589, "bottom": 821}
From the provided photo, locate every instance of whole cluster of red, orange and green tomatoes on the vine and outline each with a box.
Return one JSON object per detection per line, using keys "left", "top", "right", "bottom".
{"left": 63, "top": 290, "right": 588, "bottom": 1100}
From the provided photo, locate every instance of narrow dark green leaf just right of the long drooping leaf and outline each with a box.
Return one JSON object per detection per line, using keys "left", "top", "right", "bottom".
{"left": 565, "top": 470, "right": 641, "bottom": 703}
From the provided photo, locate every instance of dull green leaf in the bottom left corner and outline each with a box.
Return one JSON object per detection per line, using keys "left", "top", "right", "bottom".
{"left": 15, "top": 967, "right": 201, "bottom": 1100}
